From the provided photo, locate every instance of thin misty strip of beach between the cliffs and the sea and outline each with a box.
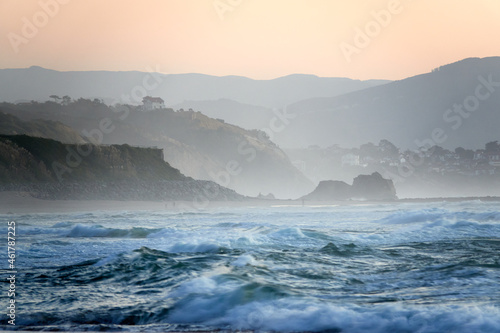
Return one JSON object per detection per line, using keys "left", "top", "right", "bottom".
{"left": 0, "top": 191, "right": 500, "bottom": 214}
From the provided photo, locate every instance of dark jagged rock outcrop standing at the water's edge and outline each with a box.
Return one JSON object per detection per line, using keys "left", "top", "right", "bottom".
{"left": 301, "top": 172, "right": 397, "bottom": 201}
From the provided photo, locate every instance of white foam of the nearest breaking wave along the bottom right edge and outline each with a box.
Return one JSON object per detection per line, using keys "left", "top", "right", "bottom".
{"left": 176, "top": 297, "right": 500, "bottom": 333}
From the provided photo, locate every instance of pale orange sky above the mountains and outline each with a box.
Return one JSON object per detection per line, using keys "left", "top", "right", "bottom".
{"left": 0, "top": 0, "right": 500, "bottom": 80}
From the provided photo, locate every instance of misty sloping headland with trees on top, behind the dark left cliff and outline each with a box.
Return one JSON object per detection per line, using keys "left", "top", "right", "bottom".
{"left": 0, "top": 99, "right": 314, "bottom": 198}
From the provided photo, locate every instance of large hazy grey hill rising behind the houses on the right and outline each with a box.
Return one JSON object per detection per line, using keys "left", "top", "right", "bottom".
{"left": 282, "top": 57, "right": 500, "bottom": 149}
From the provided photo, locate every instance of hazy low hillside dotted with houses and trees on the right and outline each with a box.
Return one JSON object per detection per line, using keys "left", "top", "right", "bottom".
{"left": 287, "top": 141, "right": 500, "bottom": 180}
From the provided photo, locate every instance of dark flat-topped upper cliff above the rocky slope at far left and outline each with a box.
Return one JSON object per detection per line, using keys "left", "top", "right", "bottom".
{"left": 0, "top": 135, "right": 186, "bottom": 183}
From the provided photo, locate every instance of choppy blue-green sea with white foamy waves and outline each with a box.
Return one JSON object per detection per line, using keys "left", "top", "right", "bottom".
{"left": 0, "top": 201, "right": 500, "bottom": 333}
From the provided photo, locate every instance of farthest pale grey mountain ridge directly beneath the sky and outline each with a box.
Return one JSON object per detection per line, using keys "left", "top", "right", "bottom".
{"left": 0, "top": 66, "right": 389, "bottom": 108}
